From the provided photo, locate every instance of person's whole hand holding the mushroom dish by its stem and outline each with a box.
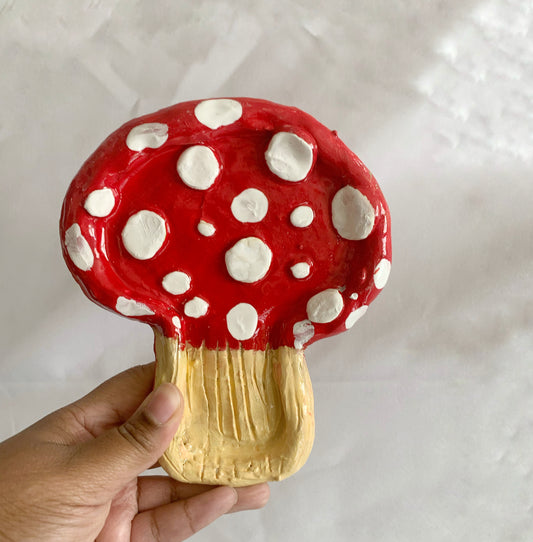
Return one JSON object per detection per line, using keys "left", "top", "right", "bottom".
{"left": 0, "top": 363, "right": 269, "bottom": 542}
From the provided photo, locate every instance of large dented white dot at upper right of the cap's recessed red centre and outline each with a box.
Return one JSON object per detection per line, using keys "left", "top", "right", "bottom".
{"left": 265, "top": 132, "right": 313, "bottom": 181}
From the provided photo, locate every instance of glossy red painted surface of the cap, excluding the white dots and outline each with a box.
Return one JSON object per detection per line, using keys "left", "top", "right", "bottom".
{"left": 60, "top": 98, "right": 391, "bottom": 349}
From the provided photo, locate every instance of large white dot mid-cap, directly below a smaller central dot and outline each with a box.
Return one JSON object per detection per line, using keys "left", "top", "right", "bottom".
{"left": 226, "top": 237, "right": 272, "bottom": 283}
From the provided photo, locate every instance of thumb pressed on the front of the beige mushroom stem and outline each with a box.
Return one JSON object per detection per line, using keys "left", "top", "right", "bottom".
{"left": 71, "top": 383, "right": 183, "bottom": 492}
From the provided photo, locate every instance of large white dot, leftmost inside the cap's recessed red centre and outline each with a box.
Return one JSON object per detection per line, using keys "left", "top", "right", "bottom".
{"left": 122, "top": 210, "right": 167, "bottom": 260}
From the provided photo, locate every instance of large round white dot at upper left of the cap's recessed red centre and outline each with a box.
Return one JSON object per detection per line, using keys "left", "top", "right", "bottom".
{"left": 177, "top": 145, "right": 220, "bottom": 190}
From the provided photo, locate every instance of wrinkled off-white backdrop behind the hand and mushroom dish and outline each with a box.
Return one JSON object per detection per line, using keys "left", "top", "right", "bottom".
{"left": 0, "top": 0, "right": 533, "bottom": 542}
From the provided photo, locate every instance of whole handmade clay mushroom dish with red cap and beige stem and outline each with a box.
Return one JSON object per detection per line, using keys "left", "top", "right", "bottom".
{"left": 61, "top": 98, "right": 391, "bottom": 486}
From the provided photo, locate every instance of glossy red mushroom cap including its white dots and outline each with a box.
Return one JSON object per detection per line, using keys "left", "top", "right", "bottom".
{"left": 61, "top": 98, "right": 391, "bottom": 349}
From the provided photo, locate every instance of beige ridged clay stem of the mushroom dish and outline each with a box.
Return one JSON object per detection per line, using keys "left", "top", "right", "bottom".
{"left": 154, "top": 329, "right": 315, "bottom": 487}
